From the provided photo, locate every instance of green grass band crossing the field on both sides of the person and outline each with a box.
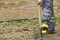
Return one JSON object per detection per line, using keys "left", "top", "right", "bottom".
{"left": 2, "top": 16, "right": 60, "bottom": 25}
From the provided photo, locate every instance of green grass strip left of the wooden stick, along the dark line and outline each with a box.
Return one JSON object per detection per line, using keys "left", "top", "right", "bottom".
{"left": 2, "top": 19, "right": 38, "bottom": 25}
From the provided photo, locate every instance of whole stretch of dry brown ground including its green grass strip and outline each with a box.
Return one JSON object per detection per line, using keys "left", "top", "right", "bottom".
{"left": 0, "top": 1, "right": 60, "bottom": 40}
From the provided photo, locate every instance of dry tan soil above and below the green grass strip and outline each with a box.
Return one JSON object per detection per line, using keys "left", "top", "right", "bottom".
{"left": 0, "top": 2, "right": 60, "bottom": 40}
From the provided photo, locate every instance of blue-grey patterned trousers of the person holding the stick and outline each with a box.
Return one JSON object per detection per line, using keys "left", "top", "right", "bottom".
{"left": 42, "top": 0, "right": 55, "bottom": 31}
